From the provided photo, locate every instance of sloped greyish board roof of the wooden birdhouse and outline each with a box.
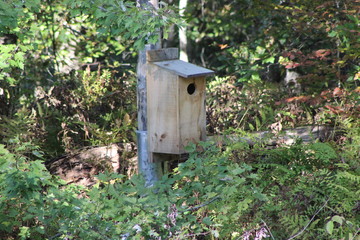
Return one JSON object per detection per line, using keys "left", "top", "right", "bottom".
{"left": 152, "top": 60, "right": 214, "bottom": 78}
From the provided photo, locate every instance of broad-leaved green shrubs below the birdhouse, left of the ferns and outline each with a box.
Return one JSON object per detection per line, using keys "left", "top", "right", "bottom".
{"left": 0, "top": 140, "right": 266, "bottom": 239}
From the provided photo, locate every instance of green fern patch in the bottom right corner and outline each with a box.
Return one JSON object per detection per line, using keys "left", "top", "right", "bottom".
{"left": 250, "top": 143, "right": 359, "bottom": 239}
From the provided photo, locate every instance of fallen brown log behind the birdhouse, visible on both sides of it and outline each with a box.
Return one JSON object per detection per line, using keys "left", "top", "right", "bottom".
{"left": 46, "top": 125, "right": 336, "bottom": 187}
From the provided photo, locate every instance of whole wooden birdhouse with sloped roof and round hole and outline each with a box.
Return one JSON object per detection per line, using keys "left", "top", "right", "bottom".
{"left": 146, "top": 48, "right": 214, "bottom": 157}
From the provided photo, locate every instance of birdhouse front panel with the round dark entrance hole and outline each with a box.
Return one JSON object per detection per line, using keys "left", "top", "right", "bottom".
{"left": 179, "top": 77, "right": 206, "bottom": 153}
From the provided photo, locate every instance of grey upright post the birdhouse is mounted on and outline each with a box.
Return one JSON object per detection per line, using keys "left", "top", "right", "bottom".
{"left": 137, "top": 0, "right": 161, "bottom": 186}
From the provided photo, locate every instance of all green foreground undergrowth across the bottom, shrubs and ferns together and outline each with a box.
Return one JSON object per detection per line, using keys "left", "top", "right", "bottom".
{"left": 0, "top": 134, "right": 360, "bottom": 239}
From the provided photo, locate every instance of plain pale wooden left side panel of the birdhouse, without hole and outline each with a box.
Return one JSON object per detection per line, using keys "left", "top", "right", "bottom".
{"left": 147, "top": 64, "right": 180, "bottom": 154}
